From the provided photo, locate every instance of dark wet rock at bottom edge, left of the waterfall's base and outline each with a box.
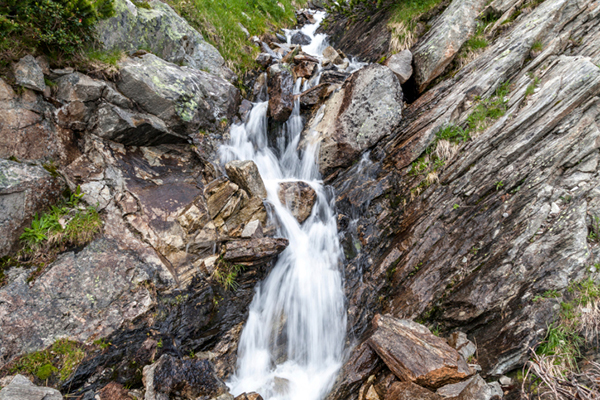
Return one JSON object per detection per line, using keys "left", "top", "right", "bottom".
{"left": 143, "top": 354, "right": 227, "bottom": 400}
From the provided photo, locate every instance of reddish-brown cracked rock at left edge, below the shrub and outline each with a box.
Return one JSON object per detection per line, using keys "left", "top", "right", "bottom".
{"left": 0, "top": 79, "right": 79, "bottom": 164}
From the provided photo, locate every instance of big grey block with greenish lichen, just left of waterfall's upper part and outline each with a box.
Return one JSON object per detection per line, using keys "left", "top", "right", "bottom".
{"left": 117, "top": 54, "right": 239, "bottom": 135}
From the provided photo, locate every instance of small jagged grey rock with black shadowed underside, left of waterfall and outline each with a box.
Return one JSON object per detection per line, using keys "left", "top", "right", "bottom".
{"left": 92, "top": 103, "right": 186, "bottom": 146}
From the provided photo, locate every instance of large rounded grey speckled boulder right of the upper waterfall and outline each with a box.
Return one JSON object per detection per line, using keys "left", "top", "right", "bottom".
{"left": 314, "top": 64, "right": 402, "bottom": 175}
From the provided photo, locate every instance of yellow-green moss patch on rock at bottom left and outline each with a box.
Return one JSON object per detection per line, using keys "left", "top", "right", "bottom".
{"left": 10, "top": 339, "right": 85, "bottom": 382}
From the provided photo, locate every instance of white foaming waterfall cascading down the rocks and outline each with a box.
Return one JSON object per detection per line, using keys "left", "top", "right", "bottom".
{"left": 221, "top": 10, "right": 346, "bottom": 400}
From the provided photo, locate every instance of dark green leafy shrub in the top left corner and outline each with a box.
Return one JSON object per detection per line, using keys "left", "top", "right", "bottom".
{"left": 0, "top": 0, "right": 114, "bottom": 67}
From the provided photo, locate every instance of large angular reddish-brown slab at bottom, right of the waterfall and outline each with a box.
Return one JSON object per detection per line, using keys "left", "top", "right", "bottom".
{"left": 368, "top": 315, "right": 471, "bottom": 389}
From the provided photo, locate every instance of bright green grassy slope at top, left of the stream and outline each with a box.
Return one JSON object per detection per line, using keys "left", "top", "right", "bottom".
{"left": 167, "top": 0, "right": 306, "bottom": 74}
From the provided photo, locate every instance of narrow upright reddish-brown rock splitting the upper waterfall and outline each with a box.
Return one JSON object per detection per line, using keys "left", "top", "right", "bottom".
{"left": 267, "top": 64, "right": 294, "bottom": 122}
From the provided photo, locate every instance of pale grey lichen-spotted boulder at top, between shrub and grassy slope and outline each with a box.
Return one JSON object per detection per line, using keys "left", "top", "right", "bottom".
{"left": 96, "top": 0, "right": 234, "bottom": 80}
